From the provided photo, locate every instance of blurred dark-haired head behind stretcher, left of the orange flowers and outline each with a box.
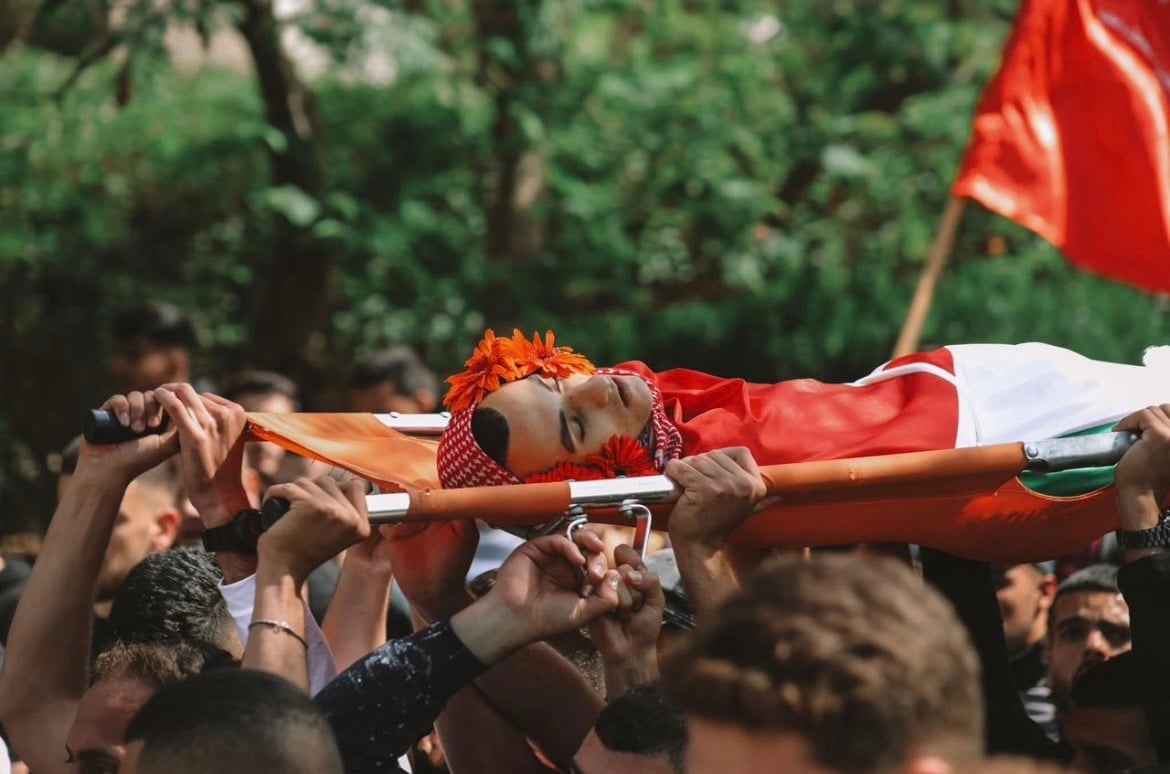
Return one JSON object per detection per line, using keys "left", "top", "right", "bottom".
{"left": 350, "top": 347, "right": 439, "bottom": 414}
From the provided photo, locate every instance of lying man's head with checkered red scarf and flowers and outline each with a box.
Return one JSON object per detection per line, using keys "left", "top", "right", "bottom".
{"left": 438, "top": 331, "right": 682, "bottom": 488}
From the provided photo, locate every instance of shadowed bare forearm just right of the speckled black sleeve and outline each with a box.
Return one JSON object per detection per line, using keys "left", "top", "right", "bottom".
{"left": 475, "top": 642, "right": 605, "bottom": 766}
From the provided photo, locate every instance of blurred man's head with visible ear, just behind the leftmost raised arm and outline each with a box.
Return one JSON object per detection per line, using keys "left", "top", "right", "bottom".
{"left": 97, "top": 463, "right": 180, "bottom": 602}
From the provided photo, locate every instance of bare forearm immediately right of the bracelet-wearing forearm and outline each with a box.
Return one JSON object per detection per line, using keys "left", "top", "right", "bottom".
{"left": 321, "top": 559, "right": 392, "bottom": 669}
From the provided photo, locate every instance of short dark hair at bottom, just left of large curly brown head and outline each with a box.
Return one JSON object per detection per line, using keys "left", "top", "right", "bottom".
{"left": 593, "top": 683, "right": 687, "bottom": 774}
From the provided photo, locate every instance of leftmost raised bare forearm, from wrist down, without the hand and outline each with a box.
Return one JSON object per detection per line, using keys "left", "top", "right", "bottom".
{"left": 0, "top": 476, "right": 125, "bottom": 772}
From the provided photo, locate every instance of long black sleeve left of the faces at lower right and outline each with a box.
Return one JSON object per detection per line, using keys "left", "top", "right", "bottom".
{"left": 921, "top": 548, "right": 1066, "bottom": 762}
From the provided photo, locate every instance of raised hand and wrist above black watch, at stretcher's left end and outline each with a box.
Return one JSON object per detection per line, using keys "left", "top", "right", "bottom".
{"left": 154, "top": 383, "right": 252, "bottom": 528}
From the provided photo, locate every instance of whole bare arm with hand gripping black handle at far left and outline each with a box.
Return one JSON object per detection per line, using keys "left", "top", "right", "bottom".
{"left": 0, "top": 393, "right": 178, "bottom": 774}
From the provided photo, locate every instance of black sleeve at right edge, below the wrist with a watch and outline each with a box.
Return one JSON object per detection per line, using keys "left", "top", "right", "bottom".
{"left": 1117, "top": 553, "right": 1170, "bottom": 763}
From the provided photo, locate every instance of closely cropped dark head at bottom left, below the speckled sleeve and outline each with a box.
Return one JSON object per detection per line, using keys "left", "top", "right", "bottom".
{"left": 119, "top": 670, "right": 342, "bottom": 774}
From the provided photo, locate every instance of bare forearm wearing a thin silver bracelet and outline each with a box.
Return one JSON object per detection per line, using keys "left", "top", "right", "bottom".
{"left": 243, "top": 561, "right": 309, "bottom": 691}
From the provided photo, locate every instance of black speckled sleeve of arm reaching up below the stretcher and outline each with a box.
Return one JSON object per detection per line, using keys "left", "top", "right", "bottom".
{"left": 314, "top": 621, "right": 487, "bottom": 772}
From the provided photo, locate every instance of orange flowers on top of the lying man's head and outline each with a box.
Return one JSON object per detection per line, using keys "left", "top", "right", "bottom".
{"left": 443, "top": 329, "right": 594, "bottom": 412}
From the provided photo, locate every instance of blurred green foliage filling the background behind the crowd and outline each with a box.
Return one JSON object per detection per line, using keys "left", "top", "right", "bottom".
{"left": 0, "top": 0, "right": 1170, "bottom": 530}
